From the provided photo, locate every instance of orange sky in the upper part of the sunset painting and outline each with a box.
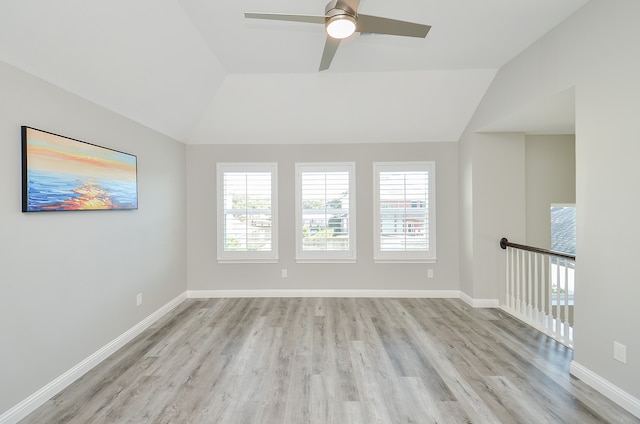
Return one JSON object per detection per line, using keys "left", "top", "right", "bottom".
{"left": 27, "top": 128, "right": 136, "bottom": 181}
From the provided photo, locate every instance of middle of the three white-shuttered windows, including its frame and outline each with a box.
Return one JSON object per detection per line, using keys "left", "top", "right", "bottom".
{"left": 296, "top": 162, "right": 356, "bottom": 262}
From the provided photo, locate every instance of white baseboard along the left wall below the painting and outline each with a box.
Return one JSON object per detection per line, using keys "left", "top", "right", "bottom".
{"left": 0, "top": 292, "right": 187, "bottom": 424}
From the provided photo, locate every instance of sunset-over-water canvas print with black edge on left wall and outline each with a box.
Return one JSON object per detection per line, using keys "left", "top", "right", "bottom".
{"left": 22, "top": 126, "right": 138, "bottom": 212}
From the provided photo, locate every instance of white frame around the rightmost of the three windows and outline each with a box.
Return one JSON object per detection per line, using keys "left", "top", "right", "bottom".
{"left": 373, "top": 161, "right": 436, "bottom": 263}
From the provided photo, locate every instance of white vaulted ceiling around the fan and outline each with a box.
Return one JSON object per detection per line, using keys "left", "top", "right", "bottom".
{"left": 0, "top": 0, "right": 588, "bottom": 143}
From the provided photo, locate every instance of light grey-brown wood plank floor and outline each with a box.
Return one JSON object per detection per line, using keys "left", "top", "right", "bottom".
{"left": 23, "top": 298, "right": 640, "bottom": 424}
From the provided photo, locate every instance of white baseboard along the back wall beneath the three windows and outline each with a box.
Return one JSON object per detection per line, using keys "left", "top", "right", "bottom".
{"left": 187, "top": 289, "right": 460, "bottom": 299}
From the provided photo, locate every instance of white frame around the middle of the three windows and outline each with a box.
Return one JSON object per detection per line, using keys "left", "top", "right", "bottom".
{"left": 295, "top": 162, "right": 357, "bottom": 263}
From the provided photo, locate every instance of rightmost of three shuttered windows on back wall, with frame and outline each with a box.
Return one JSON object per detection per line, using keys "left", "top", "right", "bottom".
{"left": 373, "top": 162, "right": 436, "bottom": 262}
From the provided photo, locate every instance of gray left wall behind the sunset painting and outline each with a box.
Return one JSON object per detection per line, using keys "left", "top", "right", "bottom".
{"left": 0, "top": 62, "right": 186, "bottom": 413}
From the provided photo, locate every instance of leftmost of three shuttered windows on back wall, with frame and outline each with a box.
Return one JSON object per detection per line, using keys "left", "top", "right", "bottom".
{"left": 217, "top": 163, "right": 278, "bottom": 262}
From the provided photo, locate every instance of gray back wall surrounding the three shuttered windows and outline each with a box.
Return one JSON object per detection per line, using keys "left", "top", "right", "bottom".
{"left": 187, "top": 143, "right": 459, "bottom": 290}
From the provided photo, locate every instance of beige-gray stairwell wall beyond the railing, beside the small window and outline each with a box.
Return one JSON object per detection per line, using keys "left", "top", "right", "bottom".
{"left": 514, "top": 135, "right": 576, "bottom": 249}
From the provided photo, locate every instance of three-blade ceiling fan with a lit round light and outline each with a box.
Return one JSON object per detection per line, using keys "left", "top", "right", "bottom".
{"left": 244, "top": 0, "right": 431, "bottom": 71}
